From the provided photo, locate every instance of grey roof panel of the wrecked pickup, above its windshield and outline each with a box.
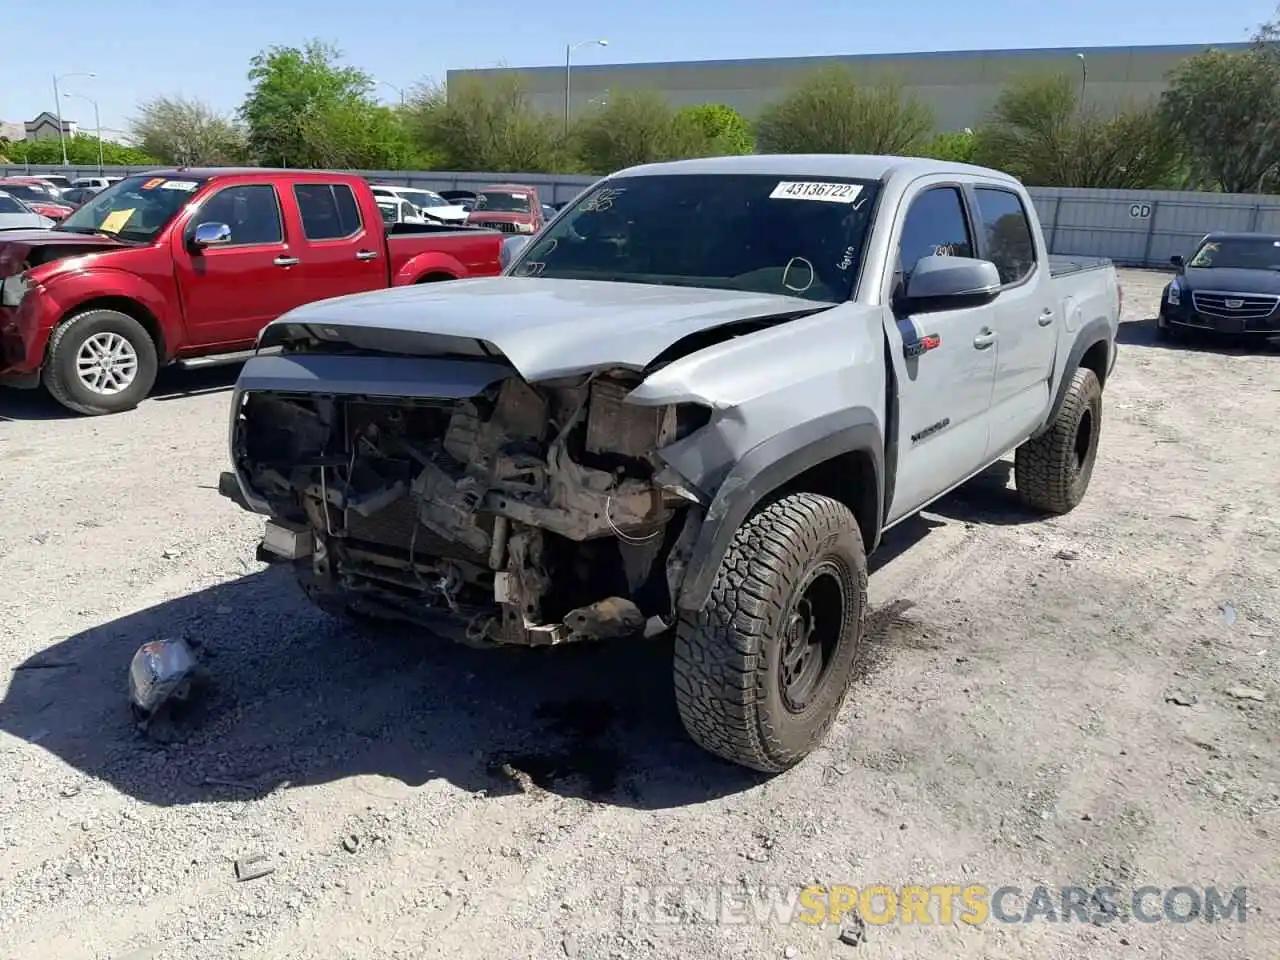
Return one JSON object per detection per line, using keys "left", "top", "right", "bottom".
{"left": 614, "top": 154, "right": 1014, "bottom": 182}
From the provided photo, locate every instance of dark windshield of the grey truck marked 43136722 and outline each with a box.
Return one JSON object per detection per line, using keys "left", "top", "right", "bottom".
{"left": 511, "top": 174, "right": 878, "bottom": 303}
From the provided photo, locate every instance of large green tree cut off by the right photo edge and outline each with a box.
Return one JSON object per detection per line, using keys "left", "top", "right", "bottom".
{"left": 1160, "top": 23, "right": 1280, "bottom": 193}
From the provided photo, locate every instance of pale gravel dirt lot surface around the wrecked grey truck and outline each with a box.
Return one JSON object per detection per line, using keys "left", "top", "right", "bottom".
{"left": 0, "top": 273, "right": 1280, "bottom": 960}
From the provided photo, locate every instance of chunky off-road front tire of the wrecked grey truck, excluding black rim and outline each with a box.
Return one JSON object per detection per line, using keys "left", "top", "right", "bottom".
{"left": 675, "top": 493, "right": 867, "bottom": 773}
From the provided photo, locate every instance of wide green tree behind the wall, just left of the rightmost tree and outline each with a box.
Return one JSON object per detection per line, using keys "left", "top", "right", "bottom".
{"left": 974, "top": 74, "right": 1183, "bottom": 189}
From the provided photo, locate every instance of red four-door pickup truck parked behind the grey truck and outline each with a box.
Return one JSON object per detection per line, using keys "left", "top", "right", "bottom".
{"left": 0, "top": 169, "right": 503, "bottom": 415}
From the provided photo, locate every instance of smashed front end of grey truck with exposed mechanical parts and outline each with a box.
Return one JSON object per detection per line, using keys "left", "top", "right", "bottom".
{"left": 224, "top": 355, "right": 710, "bottom": 645}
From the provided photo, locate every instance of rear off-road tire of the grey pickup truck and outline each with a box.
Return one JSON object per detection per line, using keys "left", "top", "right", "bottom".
{"left": 1014, "top": 367, "right": 1102, "bottom": 515}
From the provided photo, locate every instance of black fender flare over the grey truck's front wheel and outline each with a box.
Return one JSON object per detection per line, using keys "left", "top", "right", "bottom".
{"left": 676, "top": 407, "right": 884, "bottom": 611}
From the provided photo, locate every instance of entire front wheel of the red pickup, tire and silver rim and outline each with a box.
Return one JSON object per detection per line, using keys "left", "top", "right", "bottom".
{"left": 42, "top": 310, "right": 160, "bottom": 416}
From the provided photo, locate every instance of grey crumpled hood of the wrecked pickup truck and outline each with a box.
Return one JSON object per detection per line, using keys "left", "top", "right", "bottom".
{"left": 260, "top": 276, "right": 835, "bottom": 380}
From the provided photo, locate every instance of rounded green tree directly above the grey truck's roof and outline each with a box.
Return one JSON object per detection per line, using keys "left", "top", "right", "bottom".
{"left": 755, "top": 65, "right": 933, "bottom": 155}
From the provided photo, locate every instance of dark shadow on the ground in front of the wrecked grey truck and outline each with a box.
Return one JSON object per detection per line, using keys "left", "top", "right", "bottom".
{"left": 0, "top": 520, "right": 931, "bottom": 809}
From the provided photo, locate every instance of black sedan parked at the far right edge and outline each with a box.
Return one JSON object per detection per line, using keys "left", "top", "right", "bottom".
{"left": 1156, "top": 233, "right": 1280, "bottom": 338}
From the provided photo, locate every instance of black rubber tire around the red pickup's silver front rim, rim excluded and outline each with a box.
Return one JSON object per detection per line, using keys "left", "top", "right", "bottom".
{"left": 41, "top": 310, "right": 160, "bottom": 416}
